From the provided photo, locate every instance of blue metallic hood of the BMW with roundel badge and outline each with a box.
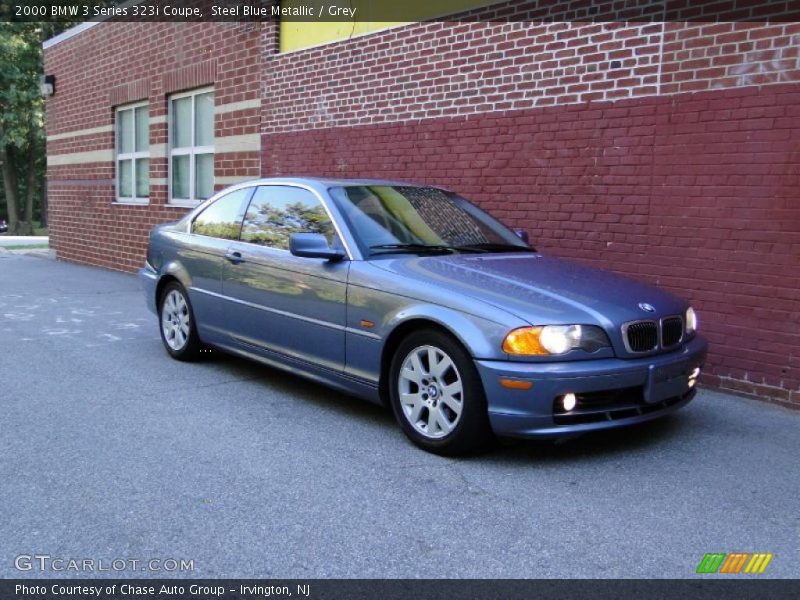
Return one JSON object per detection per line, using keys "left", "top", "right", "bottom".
{"left": 372, "top": 253, "right": 687, "bottom": 328}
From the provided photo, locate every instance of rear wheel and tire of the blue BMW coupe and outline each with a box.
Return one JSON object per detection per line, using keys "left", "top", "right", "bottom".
{"left": 158, "top": 281, "right": 203, "bottom": 361}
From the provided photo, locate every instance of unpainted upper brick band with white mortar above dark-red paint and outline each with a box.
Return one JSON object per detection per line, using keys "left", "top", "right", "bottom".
{"left": 262, "top": 21, "right": 800, "bottom": 133}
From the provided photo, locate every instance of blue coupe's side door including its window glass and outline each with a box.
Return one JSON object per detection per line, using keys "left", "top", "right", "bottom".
{"left": 222, "top": 185, "right": 350, "bottom": 371}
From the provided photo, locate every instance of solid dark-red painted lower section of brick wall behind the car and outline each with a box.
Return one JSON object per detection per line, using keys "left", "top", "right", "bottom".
{"left": 263, "top": 85, "right": 800, "bottom": 403}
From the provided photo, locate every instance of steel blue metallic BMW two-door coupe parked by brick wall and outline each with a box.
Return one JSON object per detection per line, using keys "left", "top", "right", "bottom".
{"left": 139, "top": 177, "right": 707, "bottom": 455}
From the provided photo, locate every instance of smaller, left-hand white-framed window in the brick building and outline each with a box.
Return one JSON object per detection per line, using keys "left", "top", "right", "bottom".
{"left": 114, "top": 102, "right": 150, "bottom": 204}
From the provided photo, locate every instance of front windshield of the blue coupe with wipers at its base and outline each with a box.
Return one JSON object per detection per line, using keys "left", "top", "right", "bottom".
{"left": 330, "top": 185, "right": 531, "bottom": 256}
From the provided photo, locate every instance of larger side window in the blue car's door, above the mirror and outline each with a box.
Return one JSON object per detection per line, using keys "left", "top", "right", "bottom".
{"left": 242, "top": 186, "right": 335, "bottom": 250}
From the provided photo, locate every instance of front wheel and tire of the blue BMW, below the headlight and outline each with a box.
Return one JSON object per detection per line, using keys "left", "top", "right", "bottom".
{"left": 388, "top": 329, "right": 493, "bottom": 456}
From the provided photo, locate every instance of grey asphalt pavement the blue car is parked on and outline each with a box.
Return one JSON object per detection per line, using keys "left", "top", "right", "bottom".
{"left": 0, "top": 253, "right": 800, "bottom": 578}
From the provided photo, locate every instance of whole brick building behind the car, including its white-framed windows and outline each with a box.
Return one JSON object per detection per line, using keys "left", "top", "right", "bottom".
{"left": 45, "top": 1, "right": 800, "bottom": 406}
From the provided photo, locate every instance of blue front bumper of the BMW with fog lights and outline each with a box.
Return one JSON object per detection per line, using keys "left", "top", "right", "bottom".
{"left": 475, "top": 336, "right": 708, "bottom": 438}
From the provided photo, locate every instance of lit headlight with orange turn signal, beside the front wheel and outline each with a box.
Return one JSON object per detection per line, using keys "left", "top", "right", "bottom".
{"left": 503, "top": 325, "right": 610, "bottom": 356}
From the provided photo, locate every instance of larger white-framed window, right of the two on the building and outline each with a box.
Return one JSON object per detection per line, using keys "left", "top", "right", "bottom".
{"left": 169, "top": 88, "right": 214, "bottom": 204}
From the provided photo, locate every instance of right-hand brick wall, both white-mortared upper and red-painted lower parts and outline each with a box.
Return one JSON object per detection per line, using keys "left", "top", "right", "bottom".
{"left": 262, "top": 16, "right": 800, "bottom": 405}
